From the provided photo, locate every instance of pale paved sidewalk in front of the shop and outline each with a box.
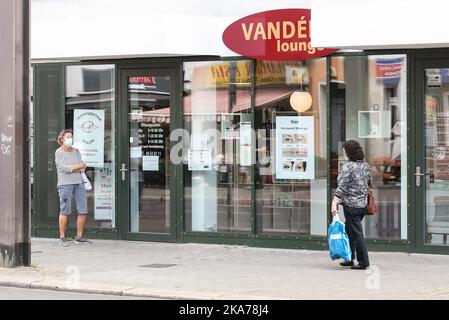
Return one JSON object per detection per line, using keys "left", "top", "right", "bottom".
{"left": 0, "top": 238, "right": 449, "bottom": 300}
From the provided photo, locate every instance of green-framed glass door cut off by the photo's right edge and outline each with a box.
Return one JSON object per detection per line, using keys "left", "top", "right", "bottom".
{"left": 414, "top": 60, "right": 449, "bottom": 252}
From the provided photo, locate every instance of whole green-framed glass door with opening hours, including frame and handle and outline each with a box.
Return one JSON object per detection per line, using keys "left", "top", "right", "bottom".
{"left": 119, "top": 69, "right": 176, "bottom": 241}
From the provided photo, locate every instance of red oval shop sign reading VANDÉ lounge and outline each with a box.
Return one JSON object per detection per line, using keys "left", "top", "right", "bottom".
{"left": 223, "top": 9, "right": 337, "bottom": 61}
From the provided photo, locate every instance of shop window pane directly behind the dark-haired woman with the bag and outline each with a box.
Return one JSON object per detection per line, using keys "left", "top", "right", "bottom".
{"left": 330, "top": 55, "right": 407, "bottom": 239}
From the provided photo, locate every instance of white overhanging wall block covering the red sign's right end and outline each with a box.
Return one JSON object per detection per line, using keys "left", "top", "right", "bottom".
{"left": 311, "top": 0, "right": 449, "bottom": 49}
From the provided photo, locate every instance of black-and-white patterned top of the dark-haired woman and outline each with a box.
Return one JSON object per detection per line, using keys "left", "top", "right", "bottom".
{"left": 335, "top": 161, "right": 371, "bottom": 208}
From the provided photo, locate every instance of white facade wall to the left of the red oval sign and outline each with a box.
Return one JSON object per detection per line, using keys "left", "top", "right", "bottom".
{"left": 31, "top": 0, "right": 310, "bottom": 59}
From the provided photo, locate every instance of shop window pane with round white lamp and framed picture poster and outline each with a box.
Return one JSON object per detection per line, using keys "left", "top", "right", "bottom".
{"left": 254, "top": 58, "right": 328, "bottom": 236}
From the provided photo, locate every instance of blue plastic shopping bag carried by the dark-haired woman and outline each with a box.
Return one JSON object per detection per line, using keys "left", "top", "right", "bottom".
{"left": 328, "top": 214, "right": 351, "bottom": 261}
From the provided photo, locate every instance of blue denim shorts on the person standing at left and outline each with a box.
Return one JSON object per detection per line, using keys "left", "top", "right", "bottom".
{"left": 58, "top": 183, "right": 87, "bottom": 216}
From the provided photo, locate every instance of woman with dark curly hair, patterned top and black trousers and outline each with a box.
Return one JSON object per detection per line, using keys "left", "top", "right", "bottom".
{"left": 331, "top": 140, "right": 371, "bottom": 270}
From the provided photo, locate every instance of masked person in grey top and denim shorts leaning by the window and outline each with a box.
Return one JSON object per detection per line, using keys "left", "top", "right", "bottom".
{"left": 55, "top": 129, "right": 89, "bottom": 247}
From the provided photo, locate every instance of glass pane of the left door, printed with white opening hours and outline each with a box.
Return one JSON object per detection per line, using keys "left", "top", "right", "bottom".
{"left": 128, "top": 73, "right": 172, "bottom": 233}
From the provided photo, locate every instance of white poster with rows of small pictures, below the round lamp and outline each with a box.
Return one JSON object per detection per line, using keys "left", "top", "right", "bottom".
{"left": 276, "top": 116, "right": 315, "bottom": 179}
